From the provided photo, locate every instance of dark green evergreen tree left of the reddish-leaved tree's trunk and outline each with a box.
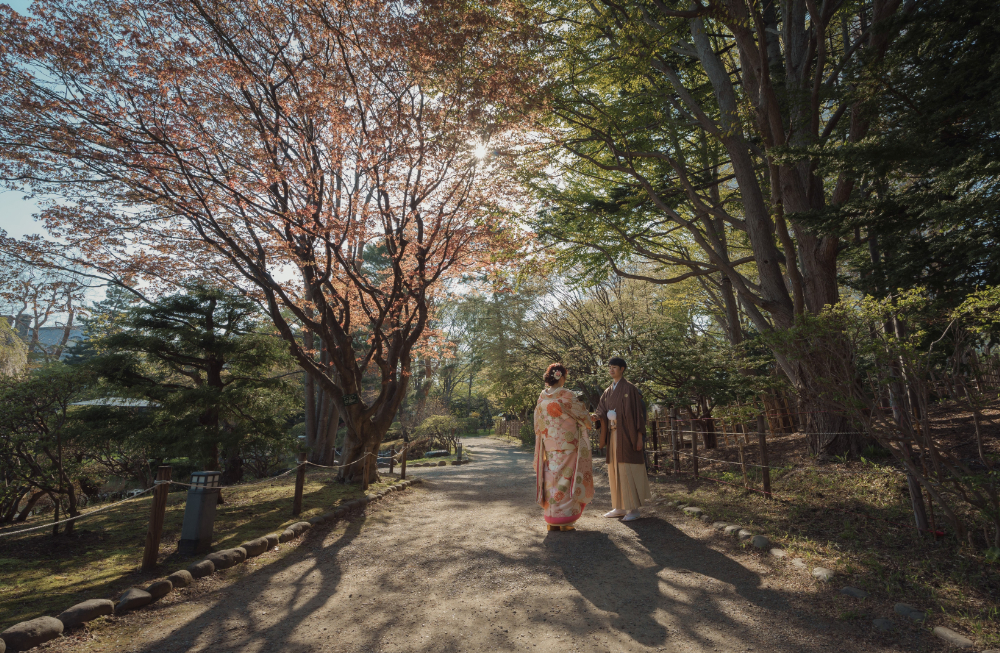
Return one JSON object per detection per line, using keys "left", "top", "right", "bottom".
{"left": 81, "top": 284, "right": 297, "bottom": 483}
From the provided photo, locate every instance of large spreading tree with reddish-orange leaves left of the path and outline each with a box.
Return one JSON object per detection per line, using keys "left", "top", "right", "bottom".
{"left": 0, "top": 0, "right": 531, "bottom": 481}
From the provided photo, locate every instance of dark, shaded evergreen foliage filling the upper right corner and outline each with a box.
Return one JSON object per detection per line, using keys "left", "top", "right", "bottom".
{"left": 807, "top": 0, "right": 1000, "bottom": 300}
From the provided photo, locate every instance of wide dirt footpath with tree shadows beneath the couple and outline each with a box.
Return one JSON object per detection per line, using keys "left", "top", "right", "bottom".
{"left": 52, "top": 438, "right": 936, "bottom": 653}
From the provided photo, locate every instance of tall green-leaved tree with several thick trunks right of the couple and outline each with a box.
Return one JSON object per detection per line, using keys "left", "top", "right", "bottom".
{"left": 524, "top": 0, "right": 903, "bottom": 453}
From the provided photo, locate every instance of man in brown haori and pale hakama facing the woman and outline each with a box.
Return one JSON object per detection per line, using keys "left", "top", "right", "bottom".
{"left": 594, "top": 356, "right": 652, "bottom": 521}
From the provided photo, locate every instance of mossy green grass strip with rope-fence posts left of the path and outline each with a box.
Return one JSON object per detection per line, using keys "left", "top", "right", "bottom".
{"left": 0, "top": 470, "right": 396, "bottom": 630}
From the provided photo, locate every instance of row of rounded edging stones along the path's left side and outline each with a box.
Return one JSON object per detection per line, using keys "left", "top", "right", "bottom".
{"left": 0, "top": 478, "right": 422, "bottom": 653}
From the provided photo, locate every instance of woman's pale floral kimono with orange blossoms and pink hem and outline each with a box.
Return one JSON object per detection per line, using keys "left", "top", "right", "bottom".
{"left": 535, "top": 388, "right": 594, "bottom": 524}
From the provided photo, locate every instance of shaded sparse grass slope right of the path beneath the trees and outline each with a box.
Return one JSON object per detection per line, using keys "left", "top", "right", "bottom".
{"left": 653, "top": 447, "right": 1000, "bottom": 648}
